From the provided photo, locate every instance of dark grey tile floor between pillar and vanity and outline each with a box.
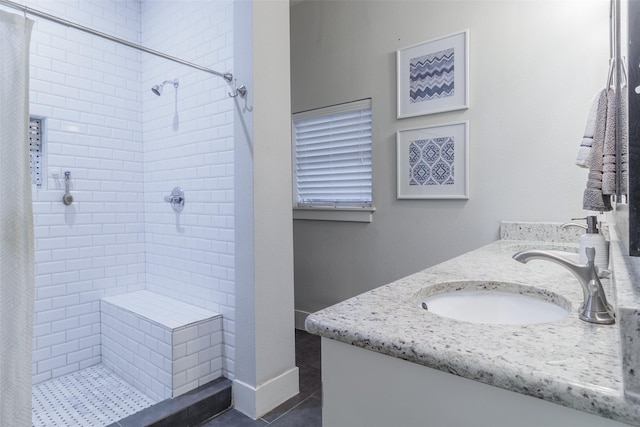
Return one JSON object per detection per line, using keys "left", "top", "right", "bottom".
{"left": 200, "top": 329, "right": 322, "bottom": 427}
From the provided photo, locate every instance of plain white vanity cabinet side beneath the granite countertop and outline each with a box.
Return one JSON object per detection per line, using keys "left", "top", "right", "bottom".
{"left": 322, "top": 337, "right": 628, "bottom": 427}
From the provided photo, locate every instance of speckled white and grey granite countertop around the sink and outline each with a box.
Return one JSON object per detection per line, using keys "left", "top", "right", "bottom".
{"left": 306, "top": 228, "right": 640, "bottom": 425}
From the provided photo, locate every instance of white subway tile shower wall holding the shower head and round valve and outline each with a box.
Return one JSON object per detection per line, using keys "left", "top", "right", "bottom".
{"left": 141, "top": 0, "right": 235, "bottom": 379}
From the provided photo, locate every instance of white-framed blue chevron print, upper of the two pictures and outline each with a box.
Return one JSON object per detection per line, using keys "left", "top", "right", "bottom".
{"left": 396, "top": 30, "right": 469, "bottom": 119}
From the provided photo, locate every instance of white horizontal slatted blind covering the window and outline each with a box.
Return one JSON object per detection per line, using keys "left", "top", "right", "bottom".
{"left": 293, "top": 99, "right": 372, "bottom": 207}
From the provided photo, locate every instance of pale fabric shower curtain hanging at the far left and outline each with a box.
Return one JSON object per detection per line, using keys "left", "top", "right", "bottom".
{"left": 0, "top": 10, "right": 34, "bottom": 426}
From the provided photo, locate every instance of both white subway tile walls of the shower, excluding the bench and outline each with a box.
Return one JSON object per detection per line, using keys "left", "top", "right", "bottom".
{"left": 24, "top": 0, "right": 234, "bottom": 383}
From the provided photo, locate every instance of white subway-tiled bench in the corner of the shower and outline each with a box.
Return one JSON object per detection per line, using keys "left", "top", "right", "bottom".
{"left": 100, "top": 291, "right": 222, "bottom": 401}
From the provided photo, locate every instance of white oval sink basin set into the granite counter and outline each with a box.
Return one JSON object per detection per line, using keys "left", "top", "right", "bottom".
{"left": 420, "top": 282, "right": 571, "bottom": 325}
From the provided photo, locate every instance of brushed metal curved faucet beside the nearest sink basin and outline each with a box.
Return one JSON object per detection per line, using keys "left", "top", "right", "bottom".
{"left": 513, "top": 248, "right": 616, "bottom": 325}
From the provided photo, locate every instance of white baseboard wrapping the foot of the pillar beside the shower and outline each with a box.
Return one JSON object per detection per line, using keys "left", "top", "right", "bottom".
{"left": 232, "top": 366, "right": 299, "bottom": 420}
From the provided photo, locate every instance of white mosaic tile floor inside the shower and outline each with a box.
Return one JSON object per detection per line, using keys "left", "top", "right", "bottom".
{"left": 31, "top": 365, "right": 157, "bottom": 427}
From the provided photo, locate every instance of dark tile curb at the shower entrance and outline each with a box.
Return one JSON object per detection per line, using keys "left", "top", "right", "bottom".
{"left": 108, "top": 377, "right": 231, "bottom": 427}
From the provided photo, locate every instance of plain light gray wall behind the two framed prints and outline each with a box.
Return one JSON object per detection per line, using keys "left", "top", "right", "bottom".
{"left": 291, "top": 0, "right": 609, "bottom": 318}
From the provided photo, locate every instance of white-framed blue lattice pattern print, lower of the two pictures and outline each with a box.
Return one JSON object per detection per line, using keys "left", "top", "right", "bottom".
{"left": 396, "top": 122, "right": 469, "bottom": 199}
